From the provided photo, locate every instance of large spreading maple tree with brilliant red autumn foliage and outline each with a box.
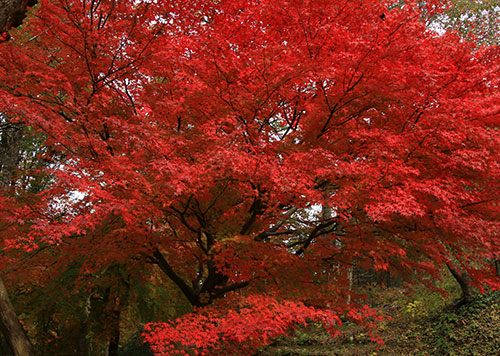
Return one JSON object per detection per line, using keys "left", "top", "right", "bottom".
{"left": 0, "top": 0, "right": 500, "bottom": 354}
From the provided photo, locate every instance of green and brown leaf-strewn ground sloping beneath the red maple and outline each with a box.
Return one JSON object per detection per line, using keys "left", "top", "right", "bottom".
{"left": 257, "top": 287, "right": 500, "bottom": 356}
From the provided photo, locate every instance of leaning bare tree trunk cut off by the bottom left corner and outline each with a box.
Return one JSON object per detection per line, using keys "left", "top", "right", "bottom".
{"left": 0, "top": 278, "right": 36, "bottom": 356}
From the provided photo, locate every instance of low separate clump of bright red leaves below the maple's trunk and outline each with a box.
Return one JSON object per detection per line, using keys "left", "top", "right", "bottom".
{"left": 144, "top": 296, "right": 342, "bottom": 355}
